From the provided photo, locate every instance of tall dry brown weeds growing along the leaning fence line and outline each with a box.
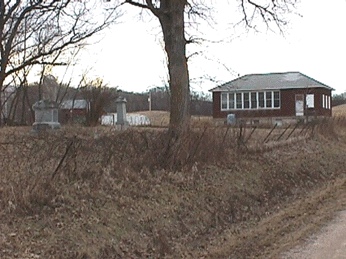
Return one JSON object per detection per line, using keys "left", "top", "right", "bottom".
{"left": 0, "top": 120, "right": 343, "bottom": 217}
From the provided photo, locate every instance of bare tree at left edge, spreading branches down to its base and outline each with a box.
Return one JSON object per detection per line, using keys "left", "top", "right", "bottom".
{"left": 0, "top": 0, "right": 122, "bottom": 126}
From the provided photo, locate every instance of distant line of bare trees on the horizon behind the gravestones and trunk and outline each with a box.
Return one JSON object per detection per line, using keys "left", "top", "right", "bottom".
{"left": 2, "top": 80, "right": 212, "bottom": 126}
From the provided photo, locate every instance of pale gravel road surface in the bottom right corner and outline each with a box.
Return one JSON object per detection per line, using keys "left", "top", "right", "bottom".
{"left": 281, "top": 211, "right": 346, "bottom": 259}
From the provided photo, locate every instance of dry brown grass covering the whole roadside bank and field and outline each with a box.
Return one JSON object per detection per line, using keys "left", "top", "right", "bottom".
{"left": 0, "top": 115, "right": 346, "bottom": 259}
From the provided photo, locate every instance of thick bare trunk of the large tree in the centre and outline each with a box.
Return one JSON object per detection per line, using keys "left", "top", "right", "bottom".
{"left": 158, "top": 0, "right": 190, "bottom": 134}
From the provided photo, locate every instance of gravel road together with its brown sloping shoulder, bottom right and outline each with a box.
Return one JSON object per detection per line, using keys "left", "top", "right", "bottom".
{"left": 197, "top": 178, "right": 346, "bottom": 259}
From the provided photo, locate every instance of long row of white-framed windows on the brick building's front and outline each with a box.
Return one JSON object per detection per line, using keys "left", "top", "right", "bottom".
{"left": 221, "top": 91, "right": 280, "bottom": 110}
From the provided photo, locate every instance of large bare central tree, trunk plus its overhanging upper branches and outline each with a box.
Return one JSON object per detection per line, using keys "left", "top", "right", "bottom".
{"left": 123, "top": 0, "right": 297, "bottom": 136}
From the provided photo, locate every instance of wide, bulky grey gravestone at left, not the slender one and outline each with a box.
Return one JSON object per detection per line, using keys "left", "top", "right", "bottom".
{"left": 32, "top": 100, "right": 60, "bottom": 132}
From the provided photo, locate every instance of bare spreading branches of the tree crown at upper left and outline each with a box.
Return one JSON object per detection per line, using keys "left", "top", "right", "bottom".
{"left": 0, "top": 0, "right": 120, "bottom": 125}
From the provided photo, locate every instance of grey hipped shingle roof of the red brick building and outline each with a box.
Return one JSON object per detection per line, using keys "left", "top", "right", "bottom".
{"left": 209, "top": 72, "right": 334, "bottom": 92}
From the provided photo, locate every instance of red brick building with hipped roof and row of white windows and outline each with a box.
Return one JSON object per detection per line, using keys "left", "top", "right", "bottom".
{"left": 210, "top": 72, "right": 334, "bottom": 123}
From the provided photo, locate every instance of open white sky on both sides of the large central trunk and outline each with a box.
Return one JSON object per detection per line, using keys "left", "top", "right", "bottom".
{"left": 61, "top": 0, "right": 346, "bottom": 93}
